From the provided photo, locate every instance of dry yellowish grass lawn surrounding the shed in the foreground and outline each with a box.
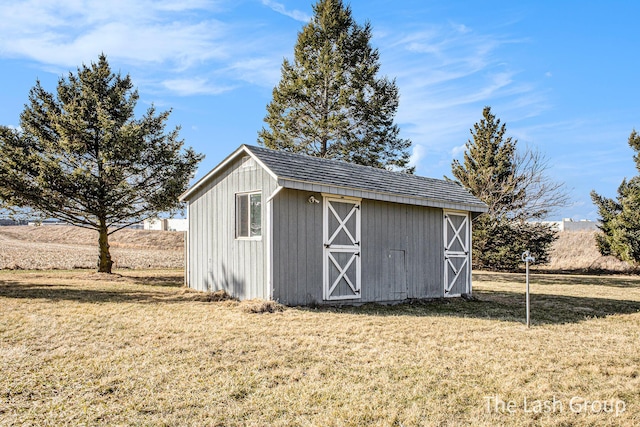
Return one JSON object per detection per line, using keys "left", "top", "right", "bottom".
{"left": 0, "top": 270, "right": 640, "bottom": 426}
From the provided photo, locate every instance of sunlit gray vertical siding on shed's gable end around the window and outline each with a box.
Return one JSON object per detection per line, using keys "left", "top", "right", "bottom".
{"left": 188, "top": 158, "right": 276, "bottom": 299}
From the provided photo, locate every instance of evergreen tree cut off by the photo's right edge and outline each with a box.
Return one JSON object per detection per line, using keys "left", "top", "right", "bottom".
{"left": 591, "top": 130, "right": 640, "bottom": 263}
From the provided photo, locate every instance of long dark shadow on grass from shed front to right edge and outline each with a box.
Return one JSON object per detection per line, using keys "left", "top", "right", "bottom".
{"left": 301, "top": 291, "right": 640, "bottom": 325}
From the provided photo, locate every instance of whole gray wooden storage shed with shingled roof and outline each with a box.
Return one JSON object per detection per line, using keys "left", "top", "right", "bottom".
{"left": 181, "top": 145, "right": 487, "bottom": 305}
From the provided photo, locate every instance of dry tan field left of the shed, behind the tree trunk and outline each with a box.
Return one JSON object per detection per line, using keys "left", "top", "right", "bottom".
{"left": 0, "top": 225, "right": 184, "bottom": 270}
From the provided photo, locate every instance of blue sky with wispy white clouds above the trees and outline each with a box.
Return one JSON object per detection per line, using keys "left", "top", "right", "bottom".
{"left": 0, "top": 0, "right": 640, "bottom": 219}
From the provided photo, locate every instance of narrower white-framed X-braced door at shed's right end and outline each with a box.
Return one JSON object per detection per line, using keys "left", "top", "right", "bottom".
{"left": 444, "top": 211, "right": 471, "bottom": 297}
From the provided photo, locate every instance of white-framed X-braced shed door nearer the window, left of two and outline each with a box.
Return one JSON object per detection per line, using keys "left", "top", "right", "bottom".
{"left": 322, "top": 196, "right": 361, "bottom": 300}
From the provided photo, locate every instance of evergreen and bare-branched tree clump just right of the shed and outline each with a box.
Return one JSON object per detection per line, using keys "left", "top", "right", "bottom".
{"left": 451, "top": 107, "right": 567, "bottom": 270}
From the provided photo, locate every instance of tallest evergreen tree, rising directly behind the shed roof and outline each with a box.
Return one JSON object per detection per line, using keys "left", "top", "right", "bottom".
{"left": 258, "top": 0, "right": 413, "bottom": 172}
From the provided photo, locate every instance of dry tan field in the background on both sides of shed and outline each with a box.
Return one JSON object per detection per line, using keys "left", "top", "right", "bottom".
{"left": 0, "top": 226, "right": 637, "bottom": 273}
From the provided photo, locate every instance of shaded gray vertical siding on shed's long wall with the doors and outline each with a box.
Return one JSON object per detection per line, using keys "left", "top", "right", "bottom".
{"left": 273, "top": 189, "right": 444, "bottom": 305}
